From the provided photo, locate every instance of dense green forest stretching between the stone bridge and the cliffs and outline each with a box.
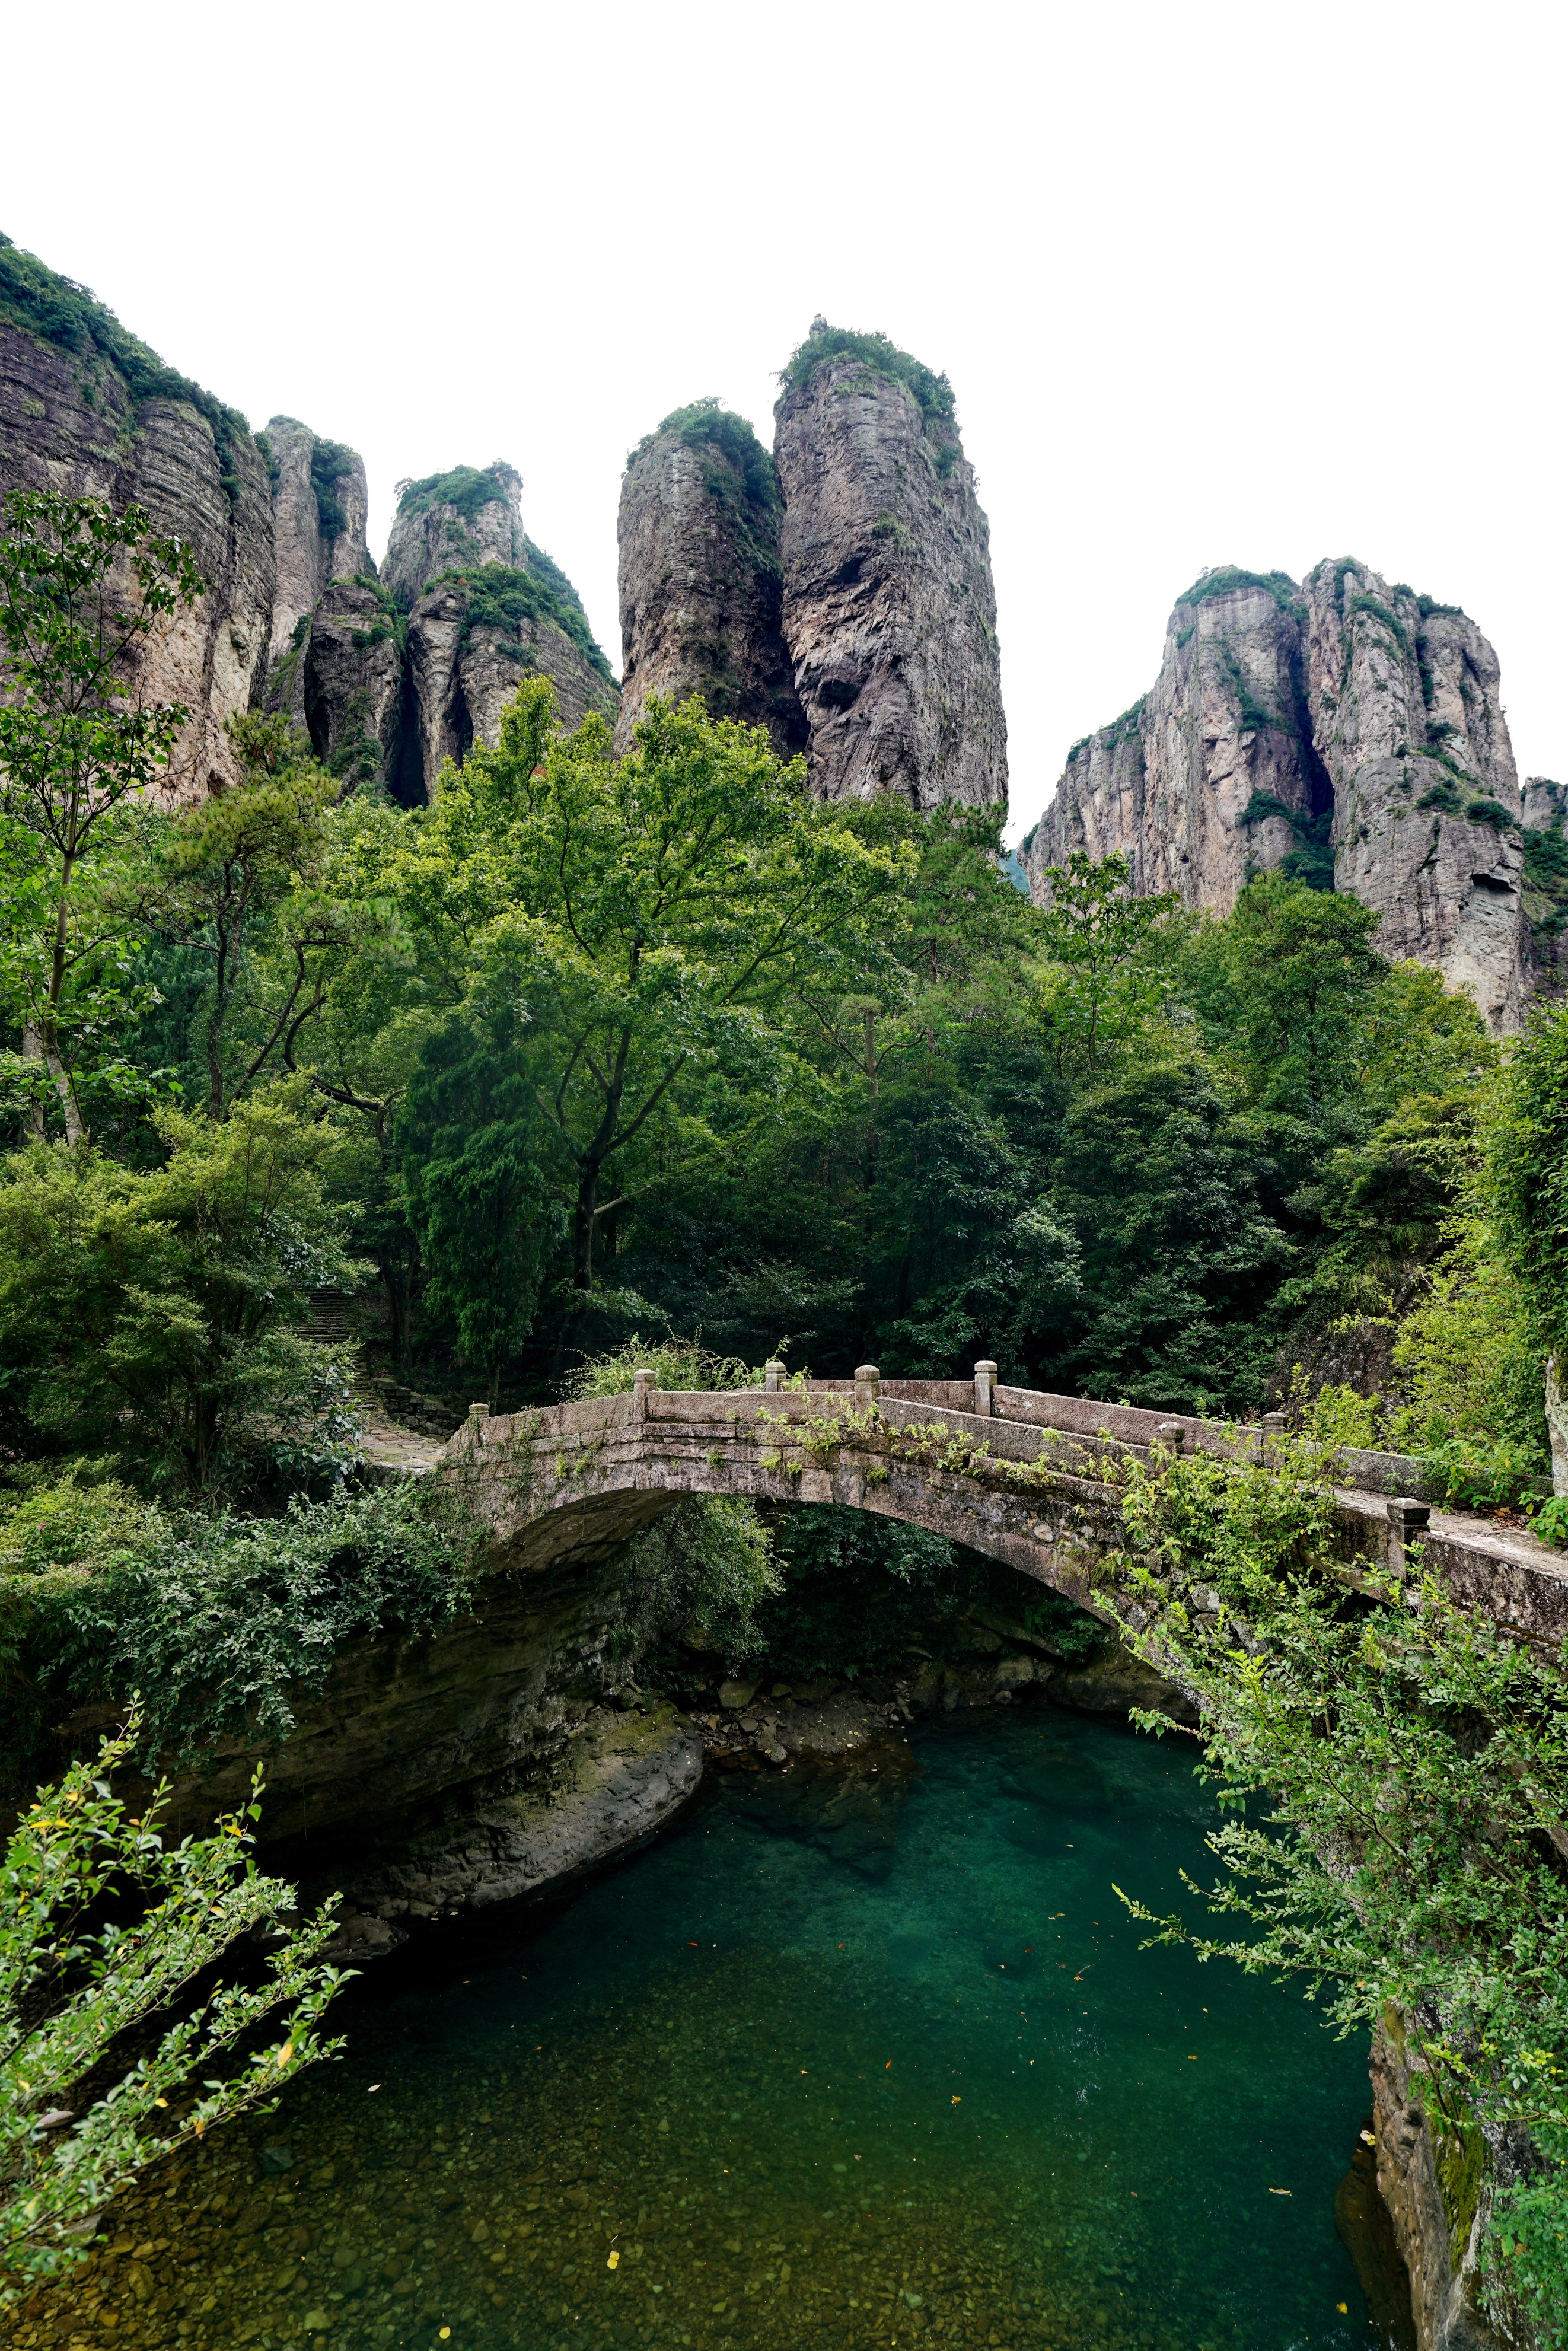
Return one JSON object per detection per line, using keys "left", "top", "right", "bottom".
{"left": 0, "top": 498, "right": 1544, "bottom": 1500}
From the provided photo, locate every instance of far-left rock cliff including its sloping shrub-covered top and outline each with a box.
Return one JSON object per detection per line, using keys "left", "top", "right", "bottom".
{"left": 0, "top": 237, "right": 278, "bottom": 799}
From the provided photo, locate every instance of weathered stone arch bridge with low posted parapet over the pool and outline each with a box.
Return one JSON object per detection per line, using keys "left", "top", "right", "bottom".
{"left": 435, "top": 1361, "right": 1568, "bottom": 1646}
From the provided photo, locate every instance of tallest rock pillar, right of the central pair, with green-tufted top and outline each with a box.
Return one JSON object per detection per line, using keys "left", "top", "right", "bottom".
{"left": 773, "top": 317, "right": 1006, "bottom": 809}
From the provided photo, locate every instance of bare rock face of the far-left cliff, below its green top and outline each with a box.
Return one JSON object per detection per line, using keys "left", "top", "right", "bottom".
{"left": 0, "top": 320, "right": 275, "bottom": 802}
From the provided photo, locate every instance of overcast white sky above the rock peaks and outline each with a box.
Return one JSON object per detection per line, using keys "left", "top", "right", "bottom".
{"left": 0, "top": 0, "right": 1568, "bottom": 839}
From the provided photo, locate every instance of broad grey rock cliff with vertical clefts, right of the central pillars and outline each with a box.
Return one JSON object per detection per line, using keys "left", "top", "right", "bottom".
{"left": 1020, "top": 559, "right": 1547, "bottom": 1032}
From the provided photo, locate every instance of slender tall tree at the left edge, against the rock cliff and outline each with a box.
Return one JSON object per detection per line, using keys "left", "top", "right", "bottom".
{"left": 0, "top": 489, "right": 202, "bottom": 1143}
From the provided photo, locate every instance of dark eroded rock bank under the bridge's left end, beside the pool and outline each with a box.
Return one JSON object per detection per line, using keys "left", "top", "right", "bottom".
{"left": 129, "top": 1514, "right": 700, "bottom": 1951}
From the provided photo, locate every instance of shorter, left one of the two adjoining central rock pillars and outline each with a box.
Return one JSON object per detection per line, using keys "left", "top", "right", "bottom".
{"left": 616, "top": 400, "right": 807, "bottom": 759}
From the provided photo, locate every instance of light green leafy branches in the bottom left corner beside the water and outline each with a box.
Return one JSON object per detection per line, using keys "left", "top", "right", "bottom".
{"left": 0, "top": 1714, "right": 346, "bottom": 2307}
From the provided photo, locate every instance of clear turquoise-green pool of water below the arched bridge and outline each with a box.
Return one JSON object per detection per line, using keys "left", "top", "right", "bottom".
{"left": 40, "top": 1707, "right": 1382, "bottom": 2351}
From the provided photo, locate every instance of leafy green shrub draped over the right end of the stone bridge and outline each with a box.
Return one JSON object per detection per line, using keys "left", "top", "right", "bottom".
{"left": 1105, "top": 1448, "right": 1568, "bottom": 2344}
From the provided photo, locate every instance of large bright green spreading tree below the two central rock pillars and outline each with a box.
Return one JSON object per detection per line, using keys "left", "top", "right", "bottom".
{"left": 402, "top": 680, "right": 907, "bottom": 1291}
